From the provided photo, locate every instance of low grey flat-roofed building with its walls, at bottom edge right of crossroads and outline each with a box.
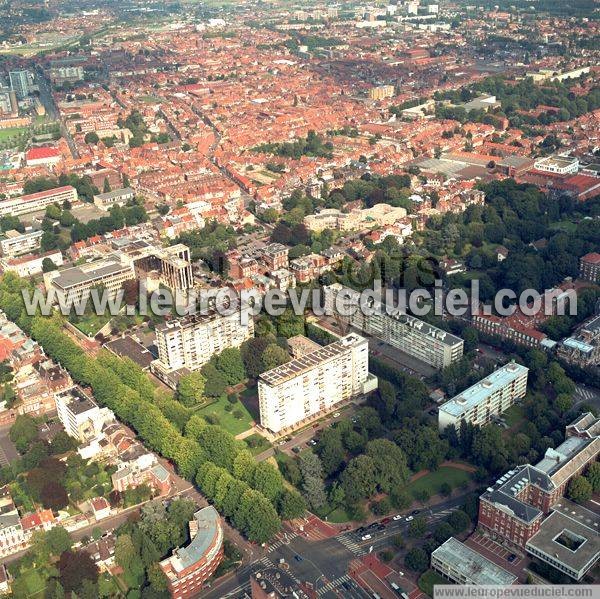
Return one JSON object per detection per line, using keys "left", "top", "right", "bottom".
{"left": 431, "top": 537, "right": 517, "bottom": 586}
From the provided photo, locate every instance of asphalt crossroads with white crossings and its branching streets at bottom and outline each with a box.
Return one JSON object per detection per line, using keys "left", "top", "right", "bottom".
{"left": 202, "top": 495, "right": 464, "bottom": 599}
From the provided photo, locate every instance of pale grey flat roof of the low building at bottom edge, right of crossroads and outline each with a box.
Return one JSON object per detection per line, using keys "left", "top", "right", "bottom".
{"left": 431, "top": 537, "right": 517, "bottom": 586}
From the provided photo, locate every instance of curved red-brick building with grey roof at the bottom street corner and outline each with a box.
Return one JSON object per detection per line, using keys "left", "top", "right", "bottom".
{"left": 159, "top": 506, "right": 223, "bottom": 599}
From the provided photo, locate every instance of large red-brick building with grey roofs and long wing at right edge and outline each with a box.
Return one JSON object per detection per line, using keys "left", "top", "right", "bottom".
{"left": 478, "top": 413, "right": 600, "bottom": 549}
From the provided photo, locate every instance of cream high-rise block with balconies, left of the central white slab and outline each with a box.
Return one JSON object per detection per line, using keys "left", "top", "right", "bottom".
{"left": 152, "top": 309, "right": 254, "bottom": 385}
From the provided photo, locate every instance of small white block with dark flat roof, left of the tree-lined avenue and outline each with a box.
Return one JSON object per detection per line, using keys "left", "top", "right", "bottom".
{"left": 54, "top": 387, "right": 115, "bottom": 443}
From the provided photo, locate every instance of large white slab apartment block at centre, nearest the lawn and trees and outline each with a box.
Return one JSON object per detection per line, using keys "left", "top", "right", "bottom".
{"left": 258, "top": 333, "right": 377, "bottom": 433}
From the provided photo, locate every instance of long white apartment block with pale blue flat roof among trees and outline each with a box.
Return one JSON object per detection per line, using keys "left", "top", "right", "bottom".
{"left": 438, "top": 362, "right": 529, "bottom": 431}
